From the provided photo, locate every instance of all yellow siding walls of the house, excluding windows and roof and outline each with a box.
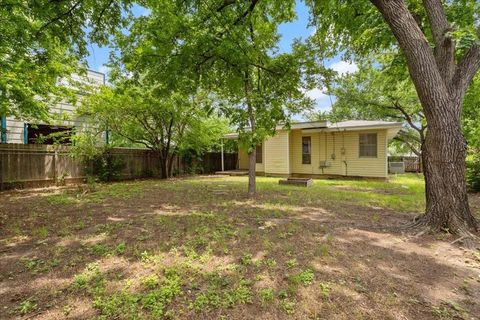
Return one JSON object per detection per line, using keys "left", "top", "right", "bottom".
{"left": 238, "top": 130, "right": 388, "bottom": 178}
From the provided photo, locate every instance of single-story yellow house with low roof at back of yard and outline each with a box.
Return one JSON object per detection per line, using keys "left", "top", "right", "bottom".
{"left": 225, "top": 120, "right": 402, "bottom": 178}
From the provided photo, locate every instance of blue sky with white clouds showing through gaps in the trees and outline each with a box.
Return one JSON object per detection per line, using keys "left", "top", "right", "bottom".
{"left": 87, "top": 1, "right": 356, "bottom": 111}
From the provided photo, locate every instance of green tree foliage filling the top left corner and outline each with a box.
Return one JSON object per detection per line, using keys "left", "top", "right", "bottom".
{"left": 0, "top": 0, "right": 129, "bottom": 119}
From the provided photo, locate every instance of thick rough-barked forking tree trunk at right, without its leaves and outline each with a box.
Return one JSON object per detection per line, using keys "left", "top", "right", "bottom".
{"left": 371, "top": 0, "right": 480, "bottom": 234}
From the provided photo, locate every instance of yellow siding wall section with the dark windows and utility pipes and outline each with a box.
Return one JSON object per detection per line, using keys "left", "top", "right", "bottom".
{"left": 290, "top": 130, "right": 387, "bottom": 177}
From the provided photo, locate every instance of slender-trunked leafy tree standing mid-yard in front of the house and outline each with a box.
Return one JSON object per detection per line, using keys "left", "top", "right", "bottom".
{"left": 112, "top": 0, "right": 314, "bottom": 195}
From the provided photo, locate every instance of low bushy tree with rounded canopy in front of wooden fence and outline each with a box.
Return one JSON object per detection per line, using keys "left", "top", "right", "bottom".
{"left": 79, "top": 79, "right": 228, "bottom": 178}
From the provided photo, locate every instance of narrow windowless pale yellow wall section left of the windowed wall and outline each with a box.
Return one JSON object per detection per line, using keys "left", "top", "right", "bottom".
{"left": 264, "top": 131, "right": 290, "bottom": 174}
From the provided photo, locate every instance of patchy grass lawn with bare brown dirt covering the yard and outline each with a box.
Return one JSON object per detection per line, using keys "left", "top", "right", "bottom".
{"left": 0, "top": 175, "right": 480, "bottom": 319}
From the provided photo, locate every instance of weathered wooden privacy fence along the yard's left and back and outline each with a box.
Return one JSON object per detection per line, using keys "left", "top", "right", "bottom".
{"left": 0, "top": 144, "right": 237, "bottom": 190}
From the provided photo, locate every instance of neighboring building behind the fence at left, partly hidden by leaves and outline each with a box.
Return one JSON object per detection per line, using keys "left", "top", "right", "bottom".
{"left": 0, "top": 70, "right": 105, "bottom": 144}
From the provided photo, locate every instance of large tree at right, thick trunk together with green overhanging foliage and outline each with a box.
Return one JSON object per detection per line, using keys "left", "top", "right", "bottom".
{"left": 308, "top": 0, "right": 480, "bottom": 235}
